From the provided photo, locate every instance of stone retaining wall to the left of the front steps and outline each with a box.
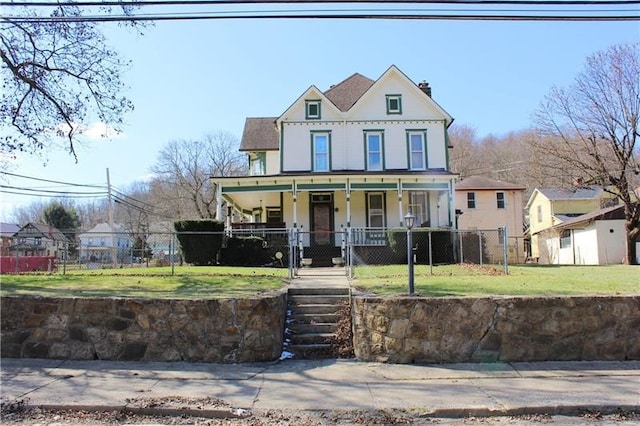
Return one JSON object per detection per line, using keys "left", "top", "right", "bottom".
{"left": 0, "top": 293, "right": 286, "bottom": 362}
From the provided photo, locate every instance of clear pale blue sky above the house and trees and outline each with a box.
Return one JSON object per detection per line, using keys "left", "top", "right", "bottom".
{"left": 0, "top": 20, "right": 640, "bottom": 221}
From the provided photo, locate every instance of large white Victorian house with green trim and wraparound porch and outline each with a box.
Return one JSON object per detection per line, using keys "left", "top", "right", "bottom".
{"left": 213, "top": 66, "right": 457, "bottom": 262}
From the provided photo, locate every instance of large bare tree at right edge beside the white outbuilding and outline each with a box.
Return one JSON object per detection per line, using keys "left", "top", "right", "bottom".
{"left": 536, "top": 43, "right": 640, "bottom": 264}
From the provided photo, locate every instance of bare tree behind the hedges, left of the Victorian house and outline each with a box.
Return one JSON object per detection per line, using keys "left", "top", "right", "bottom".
{"left": 151, "top": 132, "right": 246, "bottom": 219}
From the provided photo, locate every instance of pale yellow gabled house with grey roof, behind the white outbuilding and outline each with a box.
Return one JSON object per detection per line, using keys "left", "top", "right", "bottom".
{"left": 525, "top": 187, "right": 617, "bottom": 263}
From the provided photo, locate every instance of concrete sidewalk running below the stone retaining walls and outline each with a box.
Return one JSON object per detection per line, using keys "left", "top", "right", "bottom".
{"left": 1, "top": 358, "right": 640, "bottom": 417}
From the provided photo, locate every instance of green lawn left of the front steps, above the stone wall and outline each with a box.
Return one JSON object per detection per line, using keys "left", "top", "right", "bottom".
{"left": 0, "top": 266, "right": 287, "bottom": 299}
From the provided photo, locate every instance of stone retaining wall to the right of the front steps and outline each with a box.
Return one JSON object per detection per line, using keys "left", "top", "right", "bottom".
{"left": 352, "top": 296, "right": 640, "bottom": 363}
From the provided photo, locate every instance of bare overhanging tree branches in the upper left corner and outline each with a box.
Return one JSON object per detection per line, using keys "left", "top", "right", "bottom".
{"left": 0, "top": 0, "right": 141, "bottom": 161}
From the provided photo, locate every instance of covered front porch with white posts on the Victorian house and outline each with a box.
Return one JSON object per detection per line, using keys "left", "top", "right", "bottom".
{"left": 213, "top": 170, "right": 456, "bottom": 248}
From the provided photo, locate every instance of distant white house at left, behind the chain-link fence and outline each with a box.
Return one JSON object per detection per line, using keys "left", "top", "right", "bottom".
{"left": 79, "top": 223, "right": 133, "bottom": 263}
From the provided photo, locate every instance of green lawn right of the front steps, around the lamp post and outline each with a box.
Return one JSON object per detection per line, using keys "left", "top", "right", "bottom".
{"left": 353, "top": 265, "right": 640, "bottom": 297}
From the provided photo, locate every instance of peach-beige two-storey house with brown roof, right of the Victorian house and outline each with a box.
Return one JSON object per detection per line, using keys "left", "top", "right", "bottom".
{"left": 456, "top": 176, "right": 526, "bottom": 263}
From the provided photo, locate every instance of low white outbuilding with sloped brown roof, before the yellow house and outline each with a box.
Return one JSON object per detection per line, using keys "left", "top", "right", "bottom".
{"left": 538, "top": 206, "right": 625, "bottom": 265}
